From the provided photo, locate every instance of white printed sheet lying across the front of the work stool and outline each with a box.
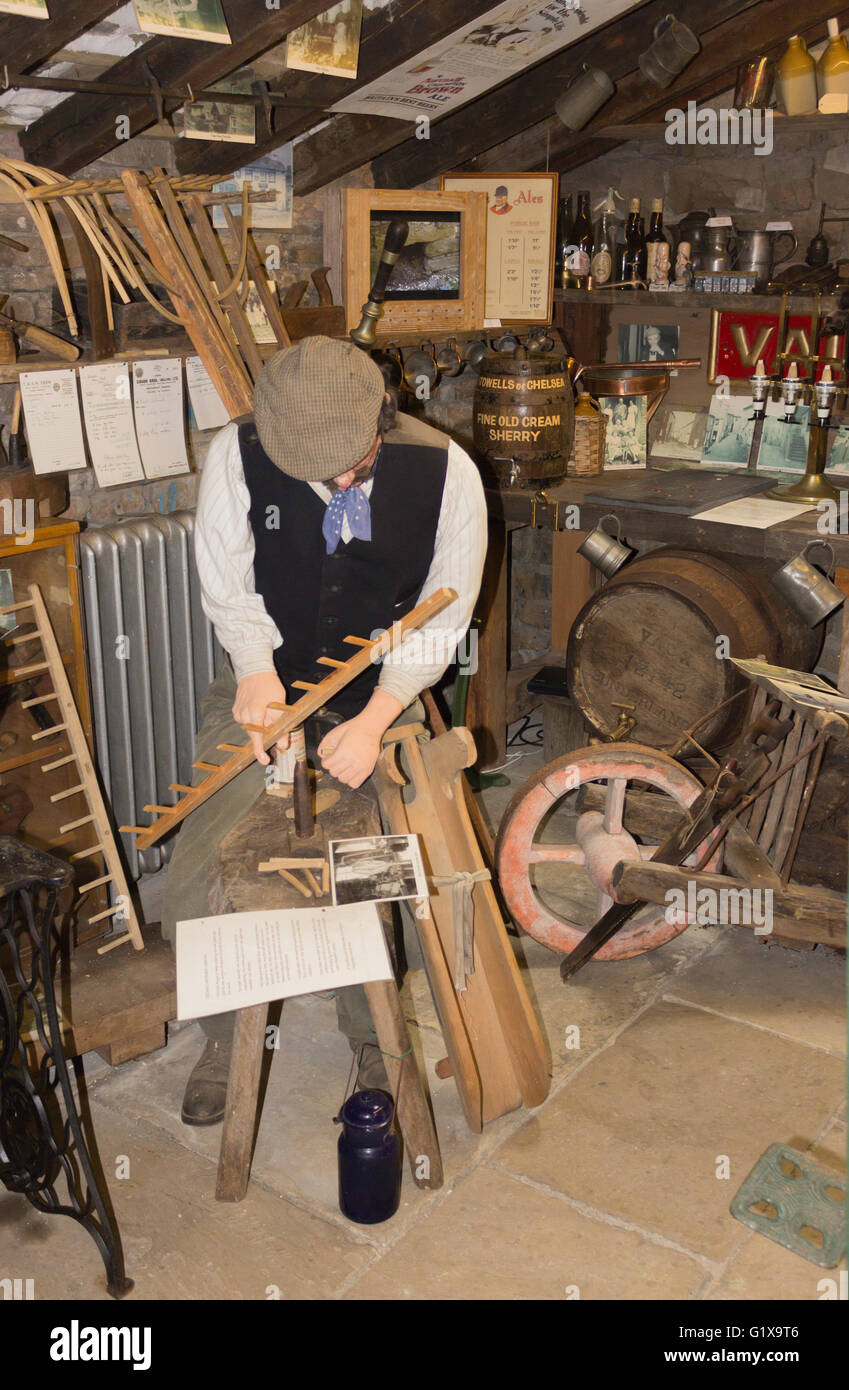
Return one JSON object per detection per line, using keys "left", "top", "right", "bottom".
{"left": 176, "top": 902, "right": 392, "bottom": 1019}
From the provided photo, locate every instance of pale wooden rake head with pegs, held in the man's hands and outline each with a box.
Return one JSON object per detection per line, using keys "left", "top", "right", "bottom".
{"left": 121, "top": 589, "right": 457, "bottom": 849}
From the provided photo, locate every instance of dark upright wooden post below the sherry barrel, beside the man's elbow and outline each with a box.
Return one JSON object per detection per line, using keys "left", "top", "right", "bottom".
{"left": 465, "top": 518, "right": 509, "bottom": 770}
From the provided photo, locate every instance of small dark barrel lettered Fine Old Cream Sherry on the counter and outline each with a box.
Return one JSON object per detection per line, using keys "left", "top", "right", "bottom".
{"left": 474, "top": 348, "right": 575, "bottom": 487}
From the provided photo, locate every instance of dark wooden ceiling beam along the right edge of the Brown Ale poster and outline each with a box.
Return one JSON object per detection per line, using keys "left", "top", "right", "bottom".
{"left": 369, "top": 0, "right": 755, "bottom": 188}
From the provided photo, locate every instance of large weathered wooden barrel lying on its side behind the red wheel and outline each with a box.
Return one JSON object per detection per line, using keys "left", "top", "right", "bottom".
{"left": 567, "top": 548, "right": 823, "bottom": 749}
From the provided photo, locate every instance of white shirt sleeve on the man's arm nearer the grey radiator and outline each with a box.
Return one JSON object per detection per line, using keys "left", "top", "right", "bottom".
{"left": 195, "top": 423, "right": 282, "bottom": 681}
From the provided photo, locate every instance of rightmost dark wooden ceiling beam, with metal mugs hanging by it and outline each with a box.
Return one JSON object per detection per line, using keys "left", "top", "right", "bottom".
{"left": 464, "top": 0, "right": 849, "bottom": 174}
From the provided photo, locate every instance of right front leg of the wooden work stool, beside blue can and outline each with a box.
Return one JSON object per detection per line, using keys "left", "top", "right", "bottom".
{"left": 365, "top": 980, "right": 443, "bottom": 1188}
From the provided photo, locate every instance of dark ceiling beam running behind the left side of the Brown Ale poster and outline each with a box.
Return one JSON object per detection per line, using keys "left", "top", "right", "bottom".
{"left": 176, "top": 0, "right": 492, "bottom": 177}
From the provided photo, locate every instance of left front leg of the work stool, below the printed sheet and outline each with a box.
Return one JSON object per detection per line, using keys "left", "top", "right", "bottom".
{"left": 215, "top": 1004, "right": 268, "bottom": 1202}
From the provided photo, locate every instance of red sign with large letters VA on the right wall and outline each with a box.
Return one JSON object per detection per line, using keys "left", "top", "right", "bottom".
{"left": 707, "top": 309, "right": 843, "bottom": 385}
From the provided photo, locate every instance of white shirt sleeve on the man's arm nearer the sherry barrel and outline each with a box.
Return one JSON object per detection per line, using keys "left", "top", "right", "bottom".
{"left": 378, "top": 441, "right": 486, "bottom": 708}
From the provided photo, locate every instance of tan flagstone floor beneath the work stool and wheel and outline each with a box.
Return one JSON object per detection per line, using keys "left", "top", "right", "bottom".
{"left": 0, "top": 751, "right": 846, "bottom": 1301}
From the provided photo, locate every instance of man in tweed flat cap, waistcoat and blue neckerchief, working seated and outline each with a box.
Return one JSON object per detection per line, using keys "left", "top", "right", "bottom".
{"left": 163, "top": 338, "right": 486, "bottom": 1125}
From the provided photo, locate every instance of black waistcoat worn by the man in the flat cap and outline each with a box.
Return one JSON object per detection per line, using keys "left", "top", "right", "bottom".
{"left": 239, "top": 421, "right": 447, "bottom": 719}
